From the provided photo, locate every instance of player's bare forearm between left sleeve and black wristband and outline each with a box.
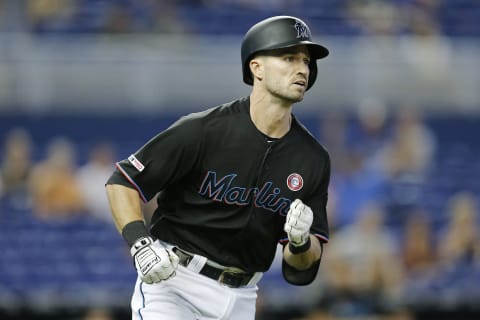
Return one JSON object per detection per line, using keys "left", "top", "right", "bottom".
{"left": 106, "top": 184, "right": 144, "bottom": 233}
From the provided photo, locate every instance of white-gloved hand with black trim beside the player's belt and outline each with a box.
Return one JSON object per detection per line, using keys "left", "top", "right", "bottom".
{"left": 130, "top": 237, "right": 178, "bottom": 284}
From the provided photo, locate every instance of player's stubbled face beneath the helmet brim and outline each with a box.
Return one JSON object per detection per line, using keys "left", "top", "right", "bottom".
{"left": 264, "top": 46, "right": 310, "bottom": 103}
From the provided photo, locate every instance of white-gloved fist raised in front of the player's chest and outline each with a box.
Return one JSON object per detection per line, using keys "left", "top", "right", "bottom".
{"left": 283, "top": 199, "right": 313, "bottom": 247}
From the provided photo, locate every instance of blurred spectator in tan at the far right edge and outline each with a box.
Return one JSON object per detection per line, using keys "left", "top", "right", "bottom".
{"left": 438, "top": 192, "right": 480, "bottom": 266}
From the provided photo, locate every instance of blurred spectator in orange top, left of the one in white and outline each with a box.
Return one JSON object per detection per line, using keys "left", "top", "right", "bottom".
{"left": 30, "top": 138, "right": 84, "bottom": 218}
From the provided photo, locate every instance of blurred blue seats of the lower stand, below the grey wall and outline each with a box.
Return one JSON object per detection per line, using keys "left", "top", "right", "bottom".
{"left": 0, "top": 115, "right": 480, "bottom": 307}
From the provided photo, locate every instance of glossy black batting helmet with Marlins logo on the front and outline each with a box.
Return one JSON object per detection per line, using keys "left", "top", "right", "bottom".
{"left": 242, "top": 16, "right": 329, "bottom": 90}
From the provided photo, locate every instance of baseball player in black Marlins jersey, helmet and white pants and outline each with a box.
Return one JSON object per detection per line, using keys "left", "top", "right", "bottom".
{"left": 106, "top": 16, "right": 330, "bottom": 320}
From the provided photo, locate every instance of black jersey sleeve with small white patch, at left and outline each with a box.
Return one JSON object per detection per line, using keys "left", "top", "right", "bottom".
{"left": 107, "top": 117, "right": 203, "bottom": 202}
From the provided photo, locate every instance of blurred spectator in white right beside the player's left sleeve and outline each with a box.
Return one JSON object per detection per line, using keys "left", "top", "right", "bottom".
{"left": 77, "top": 142, "right": 115, "bottom": 223}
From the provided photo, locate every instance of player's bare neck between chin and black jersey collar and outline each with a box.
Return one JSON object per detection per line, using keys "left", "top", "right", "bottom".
{"left": 250, "top": 94, "right": 292, "bottom": 138}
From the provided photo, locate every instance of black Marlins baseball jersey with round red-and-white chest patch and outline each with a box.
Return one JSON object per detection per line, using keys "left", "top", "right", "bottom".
{"left": 108, "top": 97, "right": 330, "bottom": 272}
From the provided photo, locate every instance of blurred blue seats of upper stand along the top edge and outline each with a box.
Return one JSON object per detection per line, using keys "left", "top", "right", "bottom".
{"left": 21, "top": 0, "right": 480, "bottom": 37}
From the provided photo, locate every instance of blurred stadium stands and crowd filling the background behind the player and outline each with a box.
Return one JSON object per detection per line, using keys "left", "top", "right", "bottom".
{"left": 0, "top": 0, "right": 480, "bottom": 320}
